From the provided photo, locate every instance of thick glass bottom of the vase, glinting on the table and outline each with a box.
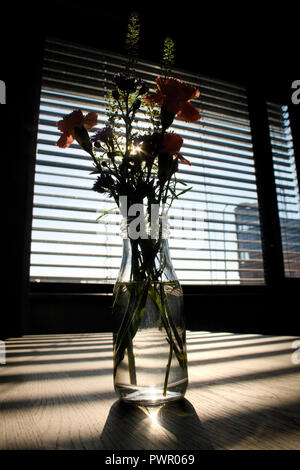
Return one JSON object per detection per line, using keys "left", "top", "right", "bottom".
{"left": 115, "top": 380, "right": 187, "bottom": 406}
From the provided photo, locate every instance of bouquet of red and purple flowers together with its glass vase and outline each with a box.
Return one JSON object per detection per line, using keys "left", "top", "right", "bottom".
{"left": 57, "top": 14, "right": 200, "bottom": 404}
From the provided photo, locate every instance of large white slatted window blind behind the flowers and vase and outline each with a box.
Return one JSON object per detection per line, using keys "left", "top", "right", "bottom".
{"left": 30, "top": 39, "right": 264, "bottom": 284}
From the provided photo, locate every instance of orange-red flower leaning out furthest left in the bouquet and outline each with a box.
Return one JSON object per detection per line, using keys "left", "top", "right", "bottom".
{"left": 56, "top": 109, "right": 98, "bottom": 148}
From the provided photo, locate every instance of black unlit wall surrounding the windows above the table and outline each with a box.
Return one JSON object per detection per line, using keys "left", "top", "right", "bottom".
{"left": 0, "top": 0, "right": 300, "bottom": 338}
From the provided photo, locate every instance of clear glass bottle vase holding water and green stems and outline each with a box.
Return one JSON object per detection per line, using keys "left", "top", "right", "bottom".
{"left": 113, "top": 218, "right": 188, "bottom": 405}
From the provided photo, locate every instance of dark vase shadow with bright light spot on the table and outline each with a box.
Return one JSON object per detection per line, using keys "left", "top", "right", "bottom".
{"left": 101, "top": 399, "right": 213, "bottom": 450}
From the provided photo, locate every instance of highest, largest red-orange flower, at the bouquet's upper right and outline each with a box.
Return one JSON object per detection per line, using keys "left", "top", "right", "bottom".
{"left": 145, "top": 77, "right": 200, "bottom": 122}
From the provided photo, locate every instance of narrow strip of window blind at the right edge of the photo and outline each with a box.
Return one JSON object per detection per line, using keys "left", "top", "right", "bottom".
{"left": 268, "top": 103, "right": 300, "bottom": 277}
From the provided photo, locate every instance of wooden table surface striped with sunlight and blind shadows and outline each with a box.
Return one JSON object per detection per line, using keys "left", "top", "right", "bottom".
{"left": 0, "top": 331, "right": 300, "bottom": 450}
